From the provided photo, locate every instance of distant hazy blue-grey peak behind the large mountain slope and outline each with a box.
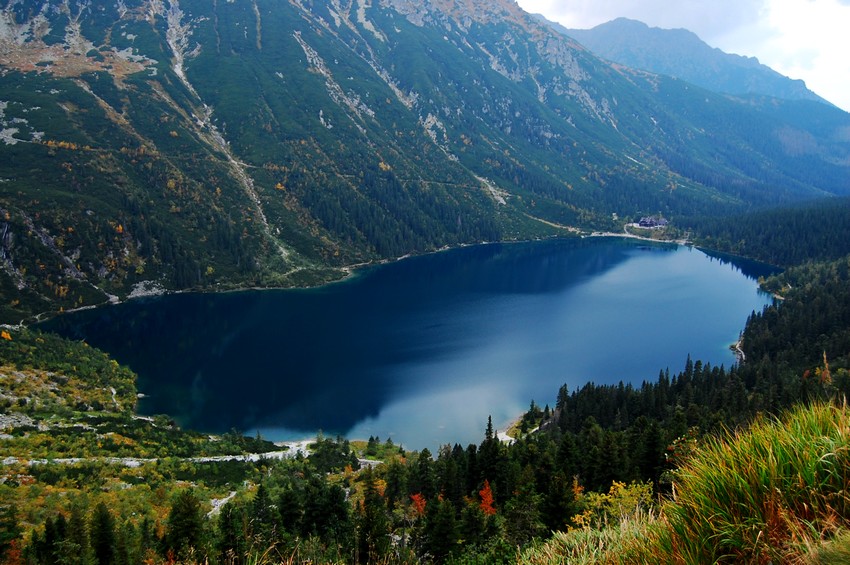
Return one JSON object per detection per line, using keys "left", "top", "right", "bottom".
{"left": 553, "top": 18, "right": 829, "bottom": 104}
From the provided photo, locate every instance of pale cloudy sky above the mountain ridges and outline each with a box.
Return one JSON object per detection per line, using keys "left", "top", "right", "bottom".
{"left": 518, "top": 0, "right": 850, "bottom": 111}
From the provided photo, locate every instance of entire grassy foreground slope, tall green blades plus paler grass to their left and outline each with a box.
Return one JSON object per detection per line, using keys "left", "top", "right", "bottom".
{"left": 520, "top": 404, "right": 850, "bottom": 564}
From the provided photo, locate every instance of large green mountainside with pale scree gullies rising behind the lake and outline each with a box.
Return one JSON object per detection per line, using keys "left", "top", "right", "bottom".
{"left": 0, "top": 0, "right": 850, "bottom": 321}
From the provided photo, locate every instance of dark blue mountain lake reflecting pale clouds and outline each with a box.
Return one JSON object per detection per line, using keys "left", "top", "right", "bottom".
{"left": 45, "top": 239, "right": 769, "bottom": 451}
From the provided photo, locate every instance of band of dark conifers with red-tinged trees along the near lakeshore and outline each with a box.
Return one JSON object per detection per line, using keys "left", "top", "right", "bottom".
{"left": 0, "top": 224, "right": 850, "bottom": 563}
